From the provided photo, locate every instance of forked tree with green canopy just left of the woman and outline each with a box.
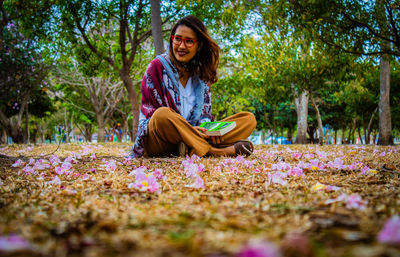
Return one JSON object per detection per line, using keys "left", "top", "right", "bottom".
{"left": 47, "top": 0, "right": 180, "bottom": 140}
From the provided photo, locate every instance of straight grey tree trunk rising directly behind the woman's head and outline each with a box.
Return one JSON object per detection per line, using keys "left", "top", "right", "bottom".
{"left": 150, "top": 0, "right": 165, "bottom": 55}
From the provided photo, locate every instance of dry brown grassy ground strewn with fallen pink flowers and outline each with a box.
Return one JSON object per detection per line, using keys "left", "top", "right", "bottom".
{"left": 0, "top": 143, "right": 400, "bottom": 256}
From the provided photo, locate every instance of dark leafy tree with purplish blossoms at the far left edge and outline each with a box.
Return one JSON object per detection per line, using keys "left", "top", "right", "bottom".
{"left": 0, "top": 17, "right": 52, "bottom": 143}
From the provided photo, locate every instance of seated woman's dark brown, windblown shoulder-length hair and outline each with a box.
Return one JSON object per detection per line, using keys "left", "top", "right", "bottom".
{"left": 169, "top": 15, "right": 220, "bottom": 84}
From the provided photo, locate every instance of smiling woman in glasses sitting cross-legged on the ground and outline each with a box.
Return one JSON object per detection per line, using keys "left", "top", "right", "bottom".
{"left": 133, "top": 16, "right": 256, "bottom": 157}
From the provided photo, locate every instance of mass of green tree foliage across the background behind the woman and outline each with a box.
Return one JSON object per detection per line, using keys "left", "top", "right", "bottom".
{"left": 0, "top": 0, "right": 400, "bottom": 142}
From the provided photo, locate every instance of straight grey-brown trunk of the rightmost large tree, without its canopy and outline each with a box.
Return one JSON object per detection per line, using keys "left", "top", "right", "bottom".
{"left": 378, "top": 55, "right": 393, "bottom": 145}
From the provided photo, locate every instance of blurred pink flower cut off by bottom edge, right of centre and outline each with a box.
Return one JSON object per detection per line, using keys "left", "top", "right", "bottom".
{"left": 237, "top": 241, "right": 281, "bottom": 257}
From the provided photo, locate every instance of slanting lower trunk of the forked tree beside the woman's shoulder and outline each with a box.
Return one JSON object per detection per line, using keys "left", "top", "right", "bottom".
{"left": 119, "top": 68, "right": 139, "bottom": 141}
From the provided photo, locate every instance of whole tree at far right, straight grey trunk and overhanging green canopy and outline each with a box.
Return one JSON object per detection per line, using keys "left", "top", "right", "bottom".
{"left": 290, "top": 0, "right": 400, "bottom": 145}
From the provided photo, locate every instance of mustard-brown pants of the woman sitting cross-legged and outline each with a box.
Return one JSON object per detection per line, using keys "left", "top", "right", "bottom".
{"left": 145, "top": 107, "right": 257, "bottom": 157}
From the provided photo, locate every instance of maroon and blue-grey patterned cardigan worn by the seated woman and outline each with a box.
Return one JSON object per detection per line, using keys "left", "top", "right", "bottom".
{"left": 131, "top": 54, "right": 213, "bottom": 158}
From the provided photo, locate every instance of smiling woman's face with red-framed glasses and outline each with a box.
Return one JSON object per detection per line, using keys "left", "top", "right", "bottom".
{"left": 172, "top": 25, "right": 199, "bottom": 62}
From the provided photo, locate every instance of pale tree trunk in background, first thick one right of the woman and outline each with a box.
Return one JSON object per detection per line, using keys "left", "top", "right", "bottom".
{"left": 294, "top": 91, "right": 308, "bottom": 144}
